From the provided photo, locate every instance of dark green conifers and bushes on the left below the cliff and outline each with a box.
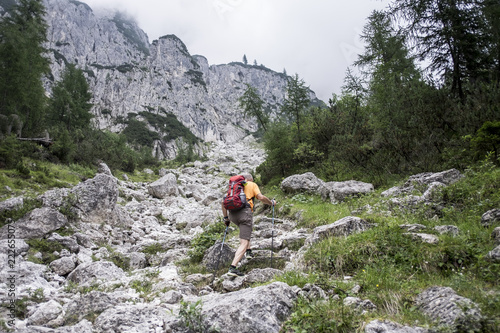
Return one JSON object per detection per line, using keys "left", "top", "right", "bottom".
{"left": 0, "top": 0, "right": 158, "bottom": 176}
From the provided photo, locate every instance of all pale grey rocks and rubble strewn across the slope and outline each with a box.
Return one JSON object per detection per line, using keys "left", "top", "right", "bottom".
{"left": 0, "top": 138, "right": 500, "bottom": 333}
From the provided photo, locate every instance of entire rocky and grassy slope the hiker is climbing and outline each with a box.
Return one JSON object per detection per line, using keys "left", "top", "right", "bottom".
{"left": 0, "top": 138, "right": 500, "bottom": 332}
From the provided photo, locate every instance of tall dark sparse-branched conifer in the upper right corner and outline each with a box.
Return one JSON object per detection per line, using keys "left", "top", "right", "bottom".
{"left": 392, "top": 0, "right": 488, "bottom": 102}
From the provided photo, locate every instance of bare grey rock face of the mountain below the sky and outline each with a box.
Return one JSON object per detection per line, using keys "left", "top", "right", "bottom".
{"left": 36, "top": 0, "right": 319, "bottom": 158}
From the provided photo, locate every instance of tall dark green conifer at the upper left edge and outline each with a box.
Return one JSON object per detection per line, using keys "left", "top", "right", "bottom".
{"left": 0, "top": 0, "right": 50, "bottom": 137}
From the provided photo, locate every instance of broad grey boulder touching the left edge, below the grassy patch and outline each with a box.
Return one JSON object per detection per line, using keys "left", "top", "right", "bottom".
{"left": 0, "top": 207, "right": 68, "bottom": 239}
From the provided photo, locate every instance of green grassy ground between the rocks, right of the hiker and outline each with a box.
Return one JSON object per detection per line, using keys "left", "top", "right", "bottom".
{"left": 270, "top": 160, "right": 500, "bottom": 332}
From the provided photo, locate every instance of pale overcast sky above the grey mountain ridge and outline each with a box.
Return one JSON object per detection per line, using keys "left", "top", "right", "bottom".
{"left": 82, "top": 0, "right": 390, "bottom": 102}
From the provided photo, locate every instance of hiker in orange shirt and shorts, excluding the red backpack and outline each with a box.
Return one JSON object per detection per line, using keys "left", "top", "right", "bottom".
{"left": 222, "top": 174, "right": 276, "bottom": 276}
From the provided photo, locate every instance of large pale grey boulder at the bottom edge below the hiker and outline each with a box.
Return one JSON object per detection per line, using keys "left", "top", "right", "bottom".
{"left": 202, "top": 282, "right": 297, "bottom": 333}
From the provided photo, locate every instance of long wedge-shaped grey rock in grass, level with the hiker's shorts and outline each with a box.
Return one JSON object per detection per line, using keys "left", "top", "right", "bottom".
{"left": 305, "top": 216, "right": 374, "bottom": 245}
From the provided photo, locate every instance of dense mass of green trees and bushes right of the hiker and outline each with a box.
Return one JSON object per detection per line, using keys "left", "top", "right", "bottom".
{"left": 258, "top": 0, "right": 500, "bottom": 185}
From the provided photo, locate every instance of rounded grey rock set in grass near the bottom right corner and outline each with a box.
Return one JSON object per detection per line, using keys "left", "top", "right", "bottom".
{"left": 416, "top": 287, "right": 482, "bottom": 332}
